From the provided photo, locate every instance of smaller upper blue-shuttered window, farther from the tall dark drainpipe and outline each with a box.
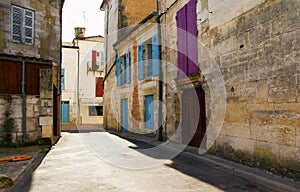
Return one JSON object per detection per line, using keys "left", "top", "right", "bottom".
{"left": 116, "top": 52, "right": 131, "bottom": 86}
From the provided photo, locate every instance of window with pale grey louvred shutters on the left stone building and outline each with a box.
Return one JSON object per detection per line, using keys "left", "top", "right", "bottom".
{"left": 11, "top": 6, "right": 34, "bottom": 44}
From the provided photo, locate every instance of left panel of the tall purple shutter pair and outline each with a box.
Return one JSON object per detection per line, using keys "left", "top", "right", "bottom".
{"left": 176, "top": 6, "right": 188, "bottom": 77}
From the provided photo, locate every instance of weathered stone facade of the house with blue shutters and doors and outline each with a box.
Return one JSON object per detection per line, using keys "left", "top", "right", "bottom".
{"left": 101, "top": 0, "right": 158, "bottom": 133}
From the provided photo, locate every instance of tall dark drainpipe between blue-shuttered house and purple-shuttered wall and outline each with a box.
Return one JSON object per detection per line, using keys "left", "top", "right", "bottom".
{"left": 156, "top": 0, "right": 163, "bottom": 141}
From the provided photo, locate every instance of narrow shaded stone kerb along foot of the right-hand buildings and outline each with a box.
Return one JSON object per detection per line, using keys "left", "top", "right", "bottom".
{"left": 108, "top": 130, "right": 300, "bottom": 192}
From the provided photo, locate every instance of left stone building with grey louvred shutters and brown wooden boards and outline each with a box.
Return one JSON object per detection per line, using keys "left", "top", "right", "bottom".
{"left": 0, "top": 0, "right": 64, "bottom": 143}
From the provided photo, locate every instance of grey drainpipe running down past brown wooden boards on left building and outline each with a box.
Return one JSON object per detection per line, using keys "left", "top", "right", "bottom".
{"left": 21, "top": 61, "right": 28, "bottom": 143}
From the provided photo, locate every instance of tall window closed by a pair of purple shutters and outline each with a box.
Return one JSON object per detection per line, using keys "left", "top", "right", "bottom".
{"left": 176, "top": 0, "right": 199, "bottom": 77}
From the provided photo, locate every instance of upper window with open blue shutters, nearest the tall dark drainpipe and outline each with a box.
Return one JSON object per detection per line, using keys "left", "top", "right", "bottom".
{"left": 138, "top": 35, "right": 159, "bottom": 80}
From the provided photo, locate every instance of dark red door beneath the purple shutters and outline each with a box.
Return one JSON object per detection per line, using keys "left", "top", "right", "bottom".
{"left": 181, "top": 88, "right": 206, "bottom": 147}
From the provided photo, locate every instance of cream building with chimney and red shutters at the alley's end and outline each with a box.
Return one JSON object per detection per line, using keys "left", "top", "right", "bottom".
{"left": 61, "top": 27, "right": 104, "bottom": 125}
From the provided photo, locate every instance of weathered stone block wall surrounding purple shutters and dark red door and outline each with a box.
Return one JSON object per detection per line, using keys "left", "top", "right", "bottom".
{"left": 163, "top": 0, "right": 300, "bottom": 178}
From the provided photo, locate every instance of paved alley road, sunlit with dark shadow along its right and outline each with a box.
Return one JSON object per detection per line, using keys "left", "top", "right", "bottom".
{"left": 8, "top": 132, "right": 290, "bottom": 192}
